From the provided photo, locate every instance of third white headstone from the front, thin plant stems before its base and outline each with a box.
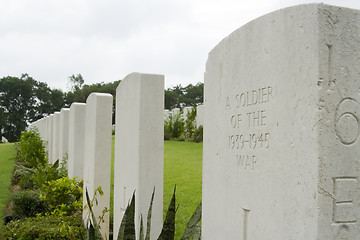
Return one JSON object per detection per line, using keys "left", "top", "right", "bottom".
{"left": 83, "top": 93, "right": 113, "bottom": 239}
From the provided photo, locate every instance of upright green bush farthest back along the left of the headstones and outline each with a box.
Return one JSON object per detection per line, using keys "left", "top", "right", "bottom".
{"left": 15, "top": 129, "right": 47, "bottom": 168}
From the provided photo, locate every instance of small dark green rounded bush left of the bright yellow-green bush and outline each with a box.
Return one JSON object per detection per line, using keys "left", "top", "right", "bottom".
{"left": 11, "top": 190, "right": 46, "bottom": 219}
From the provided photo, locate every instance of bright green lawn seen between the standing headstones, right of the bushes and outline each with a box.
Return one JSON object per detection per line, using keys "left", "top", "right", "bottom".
{"left": 110, "top": 136, "right": 203, "bottom": 239}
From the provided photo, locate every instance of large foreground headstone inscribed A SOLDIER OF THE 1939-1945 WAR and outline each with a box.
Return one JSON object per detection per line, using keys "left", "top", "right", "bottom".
{"left": 202, "top": 4, "right": 360, "bottom": 240}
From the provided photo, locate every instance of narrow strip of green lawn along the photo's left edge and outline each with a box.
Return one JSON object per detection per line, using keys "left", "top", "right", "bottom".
{"left": 0, "top": 143, "right": 15, "bottom": 229}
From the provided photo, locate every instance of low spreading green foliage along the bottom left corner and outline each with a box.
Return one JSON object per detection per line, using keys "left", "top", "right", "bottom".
{"left": 0, "top": 215, "right": 85, "bottom": 240}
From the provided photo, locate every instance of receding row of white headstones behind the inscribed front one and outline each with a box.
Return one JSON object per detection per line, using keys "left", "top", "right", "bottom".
{"left": 30, "top": 73, "right": 164, "bottom": 239}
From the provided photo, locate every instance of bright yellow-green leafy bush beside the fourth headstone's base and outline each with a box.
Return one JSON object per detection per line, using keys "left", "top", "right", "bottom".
{"left": 40, "top": 177, "right": 83, "bottom": 216}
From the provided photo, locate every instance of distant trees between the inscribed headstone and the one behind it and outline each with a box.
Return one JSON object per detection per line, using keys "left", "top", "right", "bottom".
{"left": 165, "top": 83, "right": 204, "bottom": 109}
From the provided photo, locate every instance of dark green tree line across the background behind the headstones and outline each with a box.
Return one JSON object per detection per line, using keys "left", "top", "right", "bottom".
{"left": 0, "top": 74, "right": 203, "bottom": 142}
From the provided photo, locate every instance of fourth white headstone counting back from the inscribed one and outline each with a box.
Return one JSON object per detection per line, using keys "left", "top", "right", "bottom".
{"left": 68, "top": 102, "right": 86, "bottom": 179}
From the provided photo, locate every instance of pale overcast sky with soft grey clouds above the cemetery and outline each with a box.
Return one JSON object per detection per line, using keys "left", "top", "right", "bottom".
{"left": 0, "top": 0, "right": 360, "bottom": 90}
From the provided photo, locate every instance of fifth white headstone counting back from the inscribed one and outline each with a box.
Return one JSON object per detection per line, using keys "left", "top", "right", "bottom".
{"left": 59, "top": 108, "right": 70, "bottom": 164}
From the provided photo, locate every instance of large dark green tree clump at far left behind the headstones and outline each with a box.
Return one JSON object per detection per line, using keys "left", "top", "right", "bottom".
{"left": 0, "top": 74, "right": 64, "bottom": 142}
